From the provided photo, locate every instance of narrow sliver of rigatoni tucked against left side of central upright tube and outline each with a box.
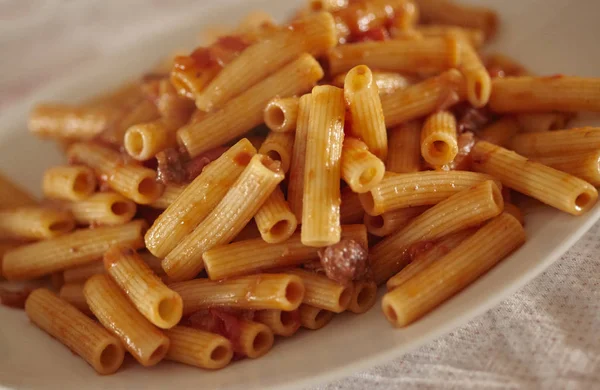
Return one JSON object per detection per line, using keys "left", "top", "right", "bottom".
{"left": 287, "top": 94, "right": 312, "bottom": 223}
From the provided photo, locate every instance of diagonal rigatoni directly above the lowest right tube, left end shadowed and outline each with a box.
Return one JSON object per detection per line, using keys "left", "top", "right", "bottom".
{"left": 370, "top": 180, "right": 504, "bottom": 285}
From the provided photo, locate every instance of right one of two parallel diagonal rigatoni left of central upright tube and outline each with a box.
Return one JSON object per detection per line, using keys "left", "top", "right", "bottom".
{"left": 163, "top": 154, "right": 283, "bottom": 281}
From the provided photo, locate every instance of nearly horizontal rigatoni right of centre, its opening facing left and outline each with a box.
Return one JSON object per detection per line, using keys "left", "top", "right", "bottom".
{"left": 359, "top": 171, "right": 493, "bottom": 215}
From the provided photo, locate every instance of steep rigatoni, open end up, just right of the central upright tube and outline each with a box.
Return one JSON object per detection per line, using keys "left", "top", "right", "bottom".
{"left": 344, "top": 65, "right": 388, "bottom": 161}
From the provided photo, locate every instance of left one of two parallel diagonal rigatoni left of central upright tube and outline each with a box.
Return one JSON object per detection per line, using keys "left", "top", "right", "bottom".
{"left": 145, "top": 138, "right": 256, "bottom": 257}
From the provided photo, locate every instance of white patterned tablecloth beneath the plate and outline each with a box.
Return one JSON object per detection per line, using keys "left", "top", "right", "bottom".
{"left": 0, "top": 0, "right": 600, "bottom": 390}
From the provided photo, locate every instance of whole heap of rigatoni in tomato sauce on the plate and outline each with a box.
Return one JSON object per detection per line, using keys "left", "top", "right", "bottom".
{"left": 0, "top": 0, "right": 600, "bottom": 374}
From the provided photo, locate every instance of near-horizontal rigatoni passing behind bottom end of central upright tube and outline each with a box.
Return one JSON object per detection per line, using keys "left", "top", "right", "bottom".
{"left": 202, "top": 225, "right": 368, "bottom": 280}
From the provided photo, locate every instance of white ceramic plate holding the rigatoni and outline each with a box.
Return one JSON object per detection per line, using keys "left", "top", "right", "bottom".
{"left": 0, "top": 0, "right": 600, "bottom": 390}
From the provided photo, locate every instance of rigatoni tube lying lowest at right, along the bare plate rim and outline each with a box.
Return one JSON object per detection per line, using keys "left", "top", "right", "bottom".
{"left": 382, "top": 214, "right": 525, "bottom": 327}
